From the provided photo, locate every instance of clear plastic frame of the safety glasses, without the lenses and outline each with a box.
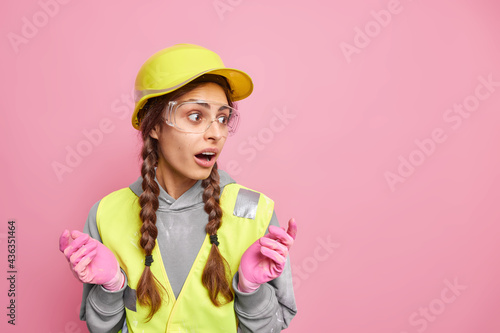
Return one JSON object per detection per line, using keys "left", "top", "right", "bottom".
{"left": 165, "top": 99, "right": 240, "bottom": 136}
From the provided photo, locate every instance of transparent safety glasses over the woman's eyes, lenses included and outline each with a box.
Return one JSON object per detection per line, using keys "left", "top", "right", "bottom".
{"left": 166, "top": 100, "right": 239, "bottom": 135}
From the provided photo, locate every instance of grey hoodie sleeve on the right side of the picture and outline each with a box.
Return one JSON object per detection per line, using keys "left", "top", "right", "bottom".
{"left": 233, "top": 212, "right": 297, "bottom": 333}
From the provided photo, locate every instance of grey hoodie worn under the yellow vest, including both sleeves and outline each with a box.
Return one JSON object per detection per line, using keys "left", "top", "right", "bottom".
{"left": 80, "top": 170, "right": 297, "bottom": 333}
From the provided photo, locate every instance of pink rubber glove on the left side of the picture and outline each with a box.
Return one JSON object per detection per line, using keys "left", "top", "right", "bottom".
{"left": 59, "top": 230, "right": 125, "bottom": 291}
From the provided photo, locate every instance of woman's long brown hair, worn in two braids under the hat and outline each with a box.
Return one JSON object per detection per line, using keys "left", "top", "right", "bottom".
{"left": 137, "top": 74, "right": 234, "bottom": 321}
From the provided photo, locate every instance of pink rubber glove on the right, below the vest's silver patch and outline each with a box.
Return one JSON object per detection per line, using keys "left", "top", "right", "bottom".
{"left": 238, "top": 218, "right": 297, "bottom": 293}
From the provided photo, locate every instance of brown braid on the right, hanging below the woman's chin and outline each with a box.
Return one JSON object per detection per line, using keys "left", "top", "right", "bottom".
{"left": 201, "top": 163, "right": 234, "bottom": 306}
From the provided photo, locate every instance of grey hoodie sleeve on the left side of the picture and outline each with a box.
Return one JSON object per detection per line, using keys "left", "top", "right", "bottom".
{"left": 80, "top": 201, "right": 128, "bottom": 333}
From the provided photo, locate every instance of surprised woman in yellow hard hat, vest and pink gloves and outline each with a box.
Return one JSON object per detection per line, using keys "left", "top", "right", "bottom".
{"left": 60, "top": 44, "right": 297, "bottom": 332}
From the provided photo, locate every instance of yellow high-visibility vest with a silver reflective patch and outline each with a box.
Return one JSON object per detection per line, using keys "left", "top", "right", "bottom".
{"left": 97, "top": 184, "right": 274, "bottom": 333}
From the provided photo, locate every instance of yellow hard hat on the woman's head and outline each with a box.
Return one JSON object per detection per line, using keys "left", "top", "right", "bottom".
{"left": 132, "top": 44, "right": 253, "bottom": 129}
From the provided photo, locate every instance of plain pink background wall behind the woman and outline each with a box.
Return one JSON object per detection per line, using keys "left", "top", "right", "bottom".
{"left": 0, "top": 0, "right": 500, "bottom": 333}
